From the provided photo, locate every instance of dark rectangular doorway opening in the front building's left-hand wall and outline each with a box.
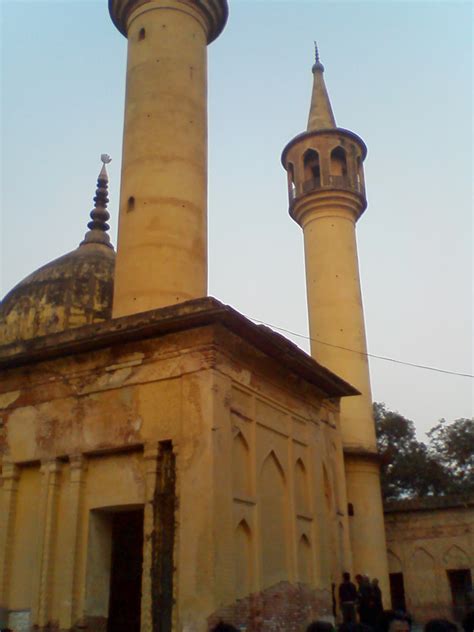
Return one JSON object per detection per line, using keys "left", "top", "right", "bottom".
{"left": 107, "top": 509, "right": 143, "bottom": 632}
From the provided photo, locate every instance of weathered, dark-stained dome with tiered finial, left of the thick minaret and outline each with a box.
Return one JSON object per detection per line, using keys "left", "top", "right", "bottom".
{"left": 0, "top": 154, "right": 115, "bottom": 344}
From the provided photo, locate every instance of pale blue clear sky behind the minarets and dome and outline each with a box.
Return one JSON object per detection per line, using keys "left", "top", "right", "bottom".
{"left": 0, "top": 0, "right": 473, "bottom": 436}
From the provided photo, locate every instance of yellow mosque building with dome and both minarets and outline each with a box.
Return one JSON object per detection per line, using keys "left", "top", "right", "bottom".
{"left": 0, "top": 0, "right": 450, "bottom": 632}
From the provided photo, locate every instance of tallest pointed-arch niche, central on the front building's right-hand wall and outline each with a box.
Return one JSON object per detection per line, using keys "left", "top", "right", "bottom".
{"left": 258, "top": 450, "right": 288, "bottom": 588}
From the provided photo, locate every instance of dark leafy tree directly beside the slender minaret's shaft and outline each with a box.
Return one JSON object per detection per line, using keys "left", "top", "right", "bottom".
{"left": 374, "top": 402, "right": 450, "bottom": 500}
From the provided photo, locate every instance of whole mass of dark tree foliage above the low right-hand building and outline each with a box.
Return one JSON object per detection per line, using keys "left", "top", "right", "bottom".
{"left": 374, "top": 402, "right": 474, "bottom": 500}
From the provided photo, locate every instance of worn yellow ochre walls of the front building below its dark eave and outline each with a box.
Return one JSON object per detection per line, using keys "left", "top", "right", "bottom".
{"left": 0, "top": 327, "right": 348, "bottom": 632}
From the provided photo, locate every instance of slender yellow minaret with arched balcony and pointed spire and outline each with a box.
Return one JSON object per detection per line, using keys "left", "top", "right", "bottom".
{"left": 282, "top": 48, "right": 389, "bottom": 598}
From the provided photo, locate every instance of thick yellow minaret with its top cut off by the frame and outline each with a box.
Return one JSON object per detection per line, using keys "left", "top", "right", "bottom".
{"left": 109, "top": 0, "right": 228, "bottom": 317}
